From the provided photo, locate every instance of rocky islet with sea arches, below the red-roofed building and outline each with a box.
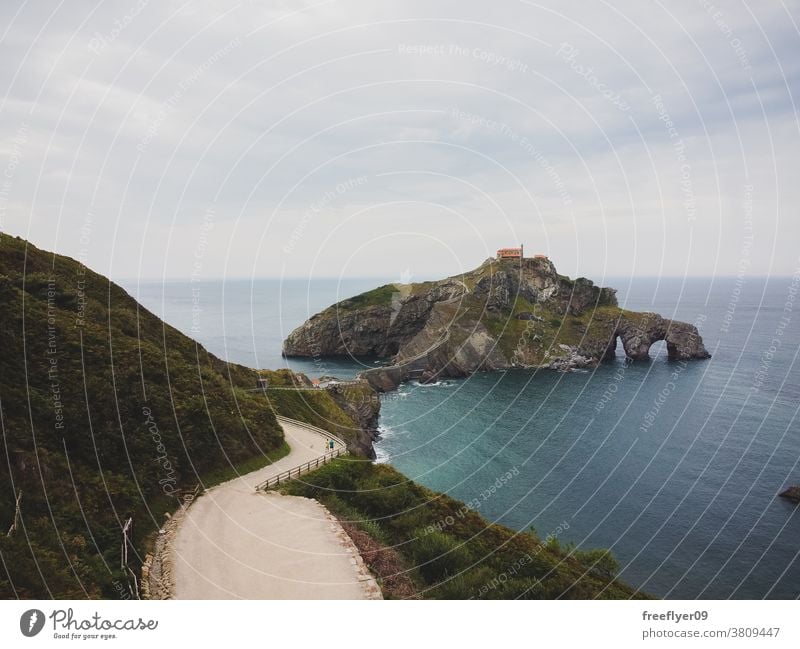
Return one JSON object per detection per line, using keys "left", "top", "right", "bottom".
{"left": 284, "top": 258, "right": 709, "bottom": 391}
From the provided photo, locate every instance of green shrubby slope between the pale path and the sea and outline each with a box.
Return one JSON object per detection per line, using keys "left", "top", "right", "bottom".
{"left": 284, "top": 459, "right": 644, "bottom": 599}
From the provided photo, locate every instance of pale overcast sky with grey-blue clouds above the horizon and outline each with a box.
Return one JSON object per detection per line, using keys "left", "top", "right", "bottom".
{"left": 0, "top": 0, "right": 800, "bottom": 283}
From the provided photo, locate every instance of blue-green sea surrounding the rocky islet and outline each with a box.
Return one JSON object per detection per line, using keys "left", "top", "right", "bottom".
{"left": 122, "top": 276, "right": 800, "bottom": 599}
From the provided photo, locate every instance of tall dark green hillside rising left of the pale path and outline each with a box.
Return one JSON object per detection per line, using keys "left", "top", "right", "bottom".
{"left": 0, "top": 235, "right": 285, "bottom": 598}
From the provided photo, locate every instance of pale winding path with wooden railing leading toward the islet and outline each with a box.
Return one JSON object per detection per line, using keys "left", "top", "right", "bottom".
{"left": 170, "top": 420, "right": 381, "bottom": 599}
